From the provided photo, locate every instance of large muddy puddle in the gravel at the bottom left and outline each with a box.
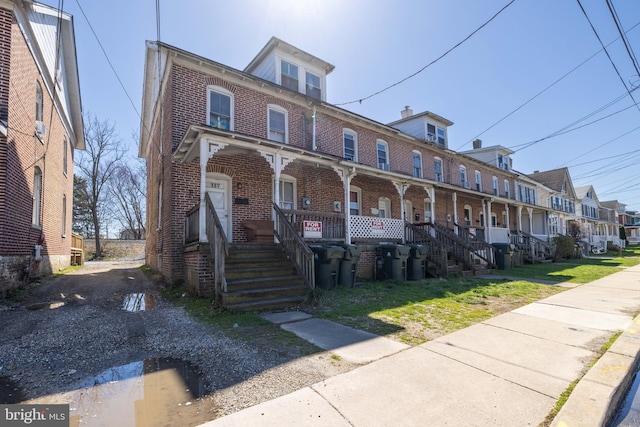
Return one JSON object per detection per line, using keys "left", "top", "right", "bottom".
{"left": 29, "top": 358, "right": 217, "bottom": 427}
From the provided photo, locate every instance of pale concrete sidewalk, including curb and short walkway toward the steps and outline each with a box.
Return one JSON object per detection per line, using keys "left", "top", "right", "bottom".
{"left": 205, "top": 266, "right": 640, "bottom": 427}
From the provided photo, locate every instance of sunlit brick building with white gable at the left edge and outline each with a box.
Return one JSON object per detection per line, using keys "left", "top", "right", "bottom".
{"left": 0, "top": 0, "right": 84, "bottom": 290}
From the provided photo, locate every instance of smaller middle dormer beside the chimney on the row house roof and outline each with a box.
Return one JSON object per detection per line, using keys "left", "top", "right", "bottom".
{"left": 387, "top": 106, "right": 453, "bottom": 148}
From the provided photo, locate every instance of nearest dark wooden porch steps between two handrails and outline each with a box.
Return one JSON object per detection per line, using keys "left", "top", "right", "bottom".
{"left": 222, "top": 243, "right": 309, "bottom": 310}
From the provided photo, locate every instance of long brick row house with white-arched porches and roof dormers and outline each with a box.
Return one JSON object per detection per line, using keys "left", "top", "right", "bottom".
{"left": 139, "top": 37, "right": 624, "bottom": 305}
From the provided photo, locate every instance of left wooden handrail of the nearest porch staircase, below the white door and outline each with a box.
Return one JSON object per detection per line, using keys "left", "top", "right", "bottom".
{"left": 204, "top": 193, "right": 229, "bottom": 299}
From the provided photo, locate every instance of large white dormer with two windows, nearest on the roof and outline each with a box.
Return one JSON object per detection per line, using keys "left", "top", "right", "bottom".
{"left": 244, "top": 37, "right": 335, "bottom": 101}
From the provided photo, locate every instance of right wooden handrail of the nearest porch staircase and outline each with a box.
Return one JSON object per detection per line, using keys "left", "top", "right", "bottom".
{"left": 273, "top": 203, "right": 316, "bottom": 289}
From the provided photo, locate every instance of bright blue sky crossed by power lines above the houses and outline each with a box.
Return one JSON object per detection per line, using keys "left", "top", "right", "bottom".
{"left": 44, "top": 0, "right": 640, "bottom": 210}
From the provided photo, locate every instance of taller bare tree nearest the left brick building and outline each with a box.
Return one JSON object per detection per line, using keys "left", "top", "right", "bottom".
{"left": 76, "top": 115, "right": 124, "bottom": 258}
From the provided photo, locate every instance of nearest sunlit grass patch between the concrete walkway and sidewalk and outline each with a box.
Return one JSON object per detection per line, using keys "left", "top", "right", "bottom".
{"left": 312, "top": 278, "right": 564, "bottom": 345}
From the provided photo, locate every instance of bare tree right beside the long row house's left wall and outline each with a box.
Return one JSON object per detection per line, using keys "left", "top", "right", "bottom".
{"left": 111, "top": 160, "right": 146, "bottom": 240}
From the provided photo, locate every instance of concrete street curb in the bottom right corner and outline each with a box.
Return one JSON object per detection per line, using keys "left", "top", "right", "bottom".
{"left": 551, "top": 316, "right": 640, "bottom": 427}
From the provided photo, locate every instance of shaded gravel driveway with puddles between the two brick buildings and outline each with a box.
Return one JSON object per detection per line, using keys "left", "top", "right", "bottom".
{"left": 0, "top": 261, "right": 355, "bottom": 426}
